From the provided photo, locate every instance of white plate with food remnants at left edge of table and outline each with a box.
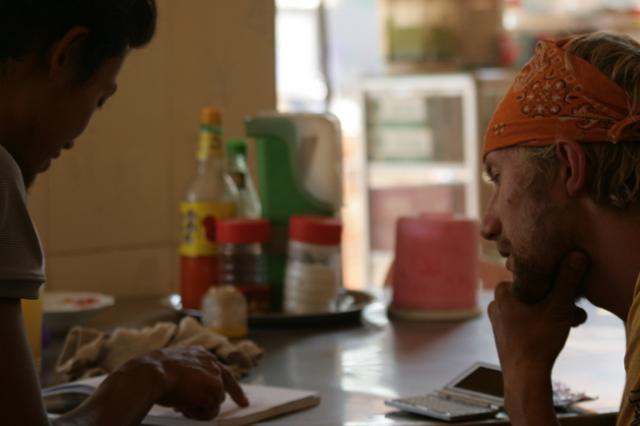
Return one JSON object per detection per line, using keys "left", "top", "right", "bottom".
{"left": 42, "top": 290, "right": 115, "bottom": 333}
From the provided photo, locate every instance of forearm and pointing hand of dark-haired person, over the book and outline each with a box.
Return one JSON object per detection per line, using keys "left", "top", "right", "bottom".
{"left": 54, "top": 346, "right": 249, "bottom": 426}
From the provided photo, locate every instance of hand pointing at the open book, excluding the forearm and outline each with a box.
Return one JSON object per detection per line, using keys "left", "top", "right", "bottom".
{"left": 114, "top": 346, "right": 249, "bottom": 420}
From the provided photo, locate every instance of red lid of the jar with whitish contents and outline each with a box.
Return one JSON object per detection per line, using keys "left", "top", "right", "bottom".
{"left": 289, "top": 216, "right": 342, "bottom": 246}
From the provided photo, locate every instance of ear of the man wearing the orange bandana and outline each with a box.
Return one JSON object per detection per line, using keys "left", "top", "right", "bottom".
{"left": 555, "top": 140, "right": 587, "bottom": 197}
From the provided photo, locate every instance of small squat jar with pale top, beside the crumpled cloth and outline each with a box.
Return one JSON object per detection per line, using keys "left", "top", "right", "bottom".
{"left": 202, "top": 285, "right": 249, "bottom": 337}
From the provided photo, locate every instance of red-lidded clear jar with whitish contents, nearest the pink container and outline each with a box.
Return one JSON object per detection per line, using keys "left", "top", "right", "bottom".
{"left": 284, "top": 216, "right": 342, "bottom": 313}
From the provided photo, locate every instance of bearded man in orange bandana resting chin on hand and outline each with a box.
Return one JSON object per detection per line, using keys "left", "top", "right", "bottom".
{"left": 482, "top": 33, "right": 640, "bottom": 426}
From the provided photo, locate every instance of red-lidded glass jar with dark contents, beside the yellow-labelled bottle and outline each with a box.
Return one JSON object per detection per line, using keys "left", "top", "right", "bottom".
{"left": 216, "top": 219, "right": 271, "bottom": 315}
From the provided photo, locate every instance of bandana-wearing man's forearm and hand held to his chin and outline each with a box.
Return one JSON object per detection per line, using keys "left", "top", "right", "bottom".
{"left": 488, "top": 252, "right": 587, "bottom": 426}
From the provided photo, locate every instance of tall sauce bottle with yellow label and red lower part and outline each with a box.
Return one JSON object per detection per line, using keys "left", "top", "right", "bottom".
{"left": 180, "top": 107, "right": 237, "bottom": 309}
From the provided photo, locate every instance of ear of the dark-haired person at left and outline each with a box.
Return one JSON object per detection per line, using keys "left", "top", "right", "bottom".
{"left": 48, "top": 27, "right": 89, "bottom": 85}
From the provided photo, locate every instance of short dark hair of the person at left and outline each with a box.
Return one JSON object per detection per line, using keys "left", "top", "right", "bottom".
{"left": 0, "top": 0, "right": 156, "bottom": 80}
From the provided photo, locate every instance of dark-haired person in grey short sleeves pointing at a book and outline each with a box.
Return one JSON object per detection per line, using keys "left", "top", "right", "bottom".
{"left": 0, "top": 0, "right": 248, "bottom": 426}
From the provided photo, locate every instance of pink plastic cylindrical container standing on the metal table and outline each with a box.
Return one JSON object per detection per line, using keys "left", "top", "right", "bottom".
{"left": 390, "top": 214, "right": 479, "bottom": 320}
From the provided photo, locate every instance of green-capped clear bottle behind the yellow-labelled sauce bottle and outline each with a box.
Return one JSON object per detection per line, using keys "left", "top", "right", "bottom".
{"left": 226, "top": 139, "right": 262, "bottom": 219}
